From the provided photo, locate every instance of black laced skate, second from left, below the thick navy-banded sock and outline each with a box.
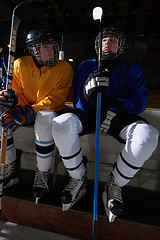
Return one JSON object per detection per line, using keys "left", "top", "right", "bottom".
{"left": 32, "top": 169, "right": 49, "bottom": 204}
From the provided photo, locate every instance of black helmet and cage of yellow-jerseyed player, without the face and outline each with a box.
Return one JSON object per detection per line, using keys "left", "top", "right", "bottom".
{"left": 26, "top": 29, "right": 59, "bottom": 66}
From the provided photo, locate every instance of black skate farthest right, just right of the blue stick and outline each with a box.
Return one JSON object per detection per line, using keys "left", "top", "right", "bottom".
{"left": 102, "top": 173, "right": 123, "bottom": 223}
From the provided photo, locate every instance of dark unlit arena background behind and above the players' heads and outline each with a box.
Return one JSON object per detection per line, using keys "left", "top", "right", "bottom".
{"left": 0, "top": 0, "right": 160, "bottom": 90}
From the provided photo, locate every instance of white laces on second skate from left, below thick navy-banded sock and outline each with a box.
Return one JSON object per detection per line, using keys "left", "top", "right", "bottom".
{"left": 33, "top": 170, "right": 49, "bottom": 189}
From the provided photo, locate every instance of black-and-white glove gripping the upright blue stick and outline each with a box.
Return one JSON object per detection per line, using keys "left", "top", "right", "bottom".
{"left": 83, "top": 70, "right": 109, "bottom": 103}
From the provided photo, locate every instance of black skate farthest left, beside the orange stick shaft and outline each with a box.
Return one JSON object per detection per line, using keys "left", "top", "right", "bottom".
{"left": 3, "top": 149, "right": 22, "bottom": 189}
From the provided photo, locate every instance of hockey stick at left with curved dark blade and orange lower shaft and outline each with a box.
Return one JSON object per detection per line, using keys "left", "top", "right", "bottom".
{"left": 0, "top": 0, "right": 44, "bottom": 210}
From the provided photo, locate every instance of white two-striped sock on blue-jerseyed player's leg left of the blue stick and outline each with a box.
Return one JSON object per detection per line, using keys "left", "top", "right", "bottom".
{"left": 52, "top": 113, "right": 86, "bottom": 179}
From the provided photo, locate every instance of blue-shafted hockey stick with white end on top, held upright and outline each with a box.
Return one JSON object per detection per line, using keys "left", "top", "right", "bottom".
{"left": 92, "top": 7, "right": 103, "bottom": 240}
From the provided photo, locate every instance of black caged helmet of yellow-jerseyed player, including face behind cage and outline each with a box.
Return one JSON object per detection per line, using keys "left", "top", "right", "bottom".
{"left": 26, "top": 29, "right": 59, "bottom": 67}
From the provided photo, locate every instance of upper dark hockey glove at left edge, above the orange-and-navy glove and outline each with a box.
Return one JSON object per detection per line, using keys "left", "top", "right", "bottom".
{"left": 0, "top": 90, "right": 18, "bottom": 111}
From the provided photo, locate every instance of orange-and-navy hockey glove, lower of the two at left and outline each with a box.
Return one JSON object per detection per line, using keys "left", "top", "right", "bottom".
{"left": 0, "top": 105, "right": 35, "bottom": 131}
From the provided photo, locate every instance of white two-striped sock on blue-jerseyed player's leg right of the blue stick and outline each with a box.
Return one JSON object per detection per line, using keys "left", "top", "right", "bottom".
{"left": 113, "top": 121, "right": 159, "bottom": 187}
